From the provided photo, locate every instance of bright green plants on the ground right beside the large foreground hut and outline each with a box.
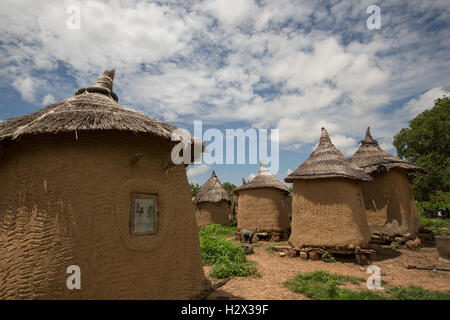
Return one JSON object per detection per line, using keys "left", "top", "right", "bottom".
{"left": 199, "top": 224, "right": 258, "bottom": 279}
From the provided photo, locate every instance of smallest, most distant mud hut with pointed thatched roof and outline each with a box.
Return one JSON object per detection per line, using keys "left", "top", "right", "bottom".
{"left": 194, "top": 170, "right": 231, "bottom": 227}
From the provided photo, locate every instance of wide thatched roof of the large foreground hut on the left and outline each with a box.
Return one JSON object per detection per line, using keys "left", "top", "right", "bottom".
{"left": 0, "top": 69, "right": 186, "bottom": 140}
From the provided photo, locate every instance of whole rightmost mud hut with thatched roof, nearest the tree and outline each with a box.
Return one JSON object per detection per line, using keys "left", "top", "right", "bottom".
{"left": 350, "top": 127, "right": 424, "bottom": 236}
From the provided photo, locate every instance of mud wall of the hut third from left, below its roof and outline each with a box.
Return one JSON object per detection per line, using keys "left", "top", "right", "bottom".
{"left": 237, "top": 188, "right": 289, "bottom": 232}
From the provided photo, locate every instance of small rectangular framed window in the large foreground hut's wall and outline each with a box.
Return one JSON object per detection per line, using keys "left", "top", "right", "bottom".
{"left": 130, "top": 194, "right": 158, "bottom": 235}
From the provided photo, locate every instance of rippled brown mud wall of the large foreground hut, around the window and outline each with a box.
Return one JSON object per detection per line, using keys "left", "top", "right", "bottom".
{"left": 0, "top": 132, "right": 205, "bottom": 299}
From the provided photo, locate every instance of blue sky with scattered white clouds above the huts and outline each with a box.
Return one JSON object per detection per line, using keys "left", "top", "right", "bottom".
{"left": 0, "top": 0, "right": 450, "bottom": 184}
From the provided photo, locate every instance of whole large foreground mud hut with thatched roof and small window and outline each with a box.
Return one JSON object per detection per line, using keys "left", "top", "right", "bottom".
{"left": 0, "top": 70, "right": 206, "bottom": 299}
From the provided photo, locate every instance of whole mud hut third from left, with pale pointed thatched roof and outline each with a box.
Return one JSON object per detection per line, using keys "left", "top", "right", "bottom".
{"left": 233, "top": 163, "right": 289, "bottom": 233}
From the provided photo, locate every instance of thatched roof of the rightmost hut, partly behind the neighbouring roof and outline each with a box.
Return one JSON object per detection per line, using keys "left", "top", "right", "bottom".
{"left": 349, "top": 127, "right": 425, "bottom": 174}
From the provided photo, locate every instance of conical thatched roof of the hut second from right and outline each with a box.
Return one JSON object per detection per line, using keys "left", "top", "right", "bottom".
{"left": 285, "top": 128, "right": 372, "bottom": 182}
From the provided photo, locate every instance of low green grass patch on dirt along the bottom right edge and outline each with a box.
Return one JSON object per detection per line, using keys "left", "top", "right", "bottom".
{"left": 284, "top": 270, "right": 450, "bottom": 300}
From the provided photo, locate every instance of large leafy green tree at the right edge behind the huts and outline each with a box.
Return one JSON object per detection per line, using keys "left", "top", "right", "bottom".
{"left": 394, "top": 96, "right": 450, "bottom": 201}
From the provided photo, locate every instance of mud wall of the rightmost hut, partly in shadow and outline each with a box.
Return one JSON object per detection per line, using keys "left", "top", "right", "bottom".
{"left": 362, "top": 168, "right": 419, "bottom": 234}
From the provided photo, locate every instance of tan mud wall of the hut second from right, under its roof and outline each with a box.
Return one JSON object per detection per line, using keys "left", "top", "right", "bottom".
{"left": 289, "top": 179, "right": 370, "bottom": 247}
